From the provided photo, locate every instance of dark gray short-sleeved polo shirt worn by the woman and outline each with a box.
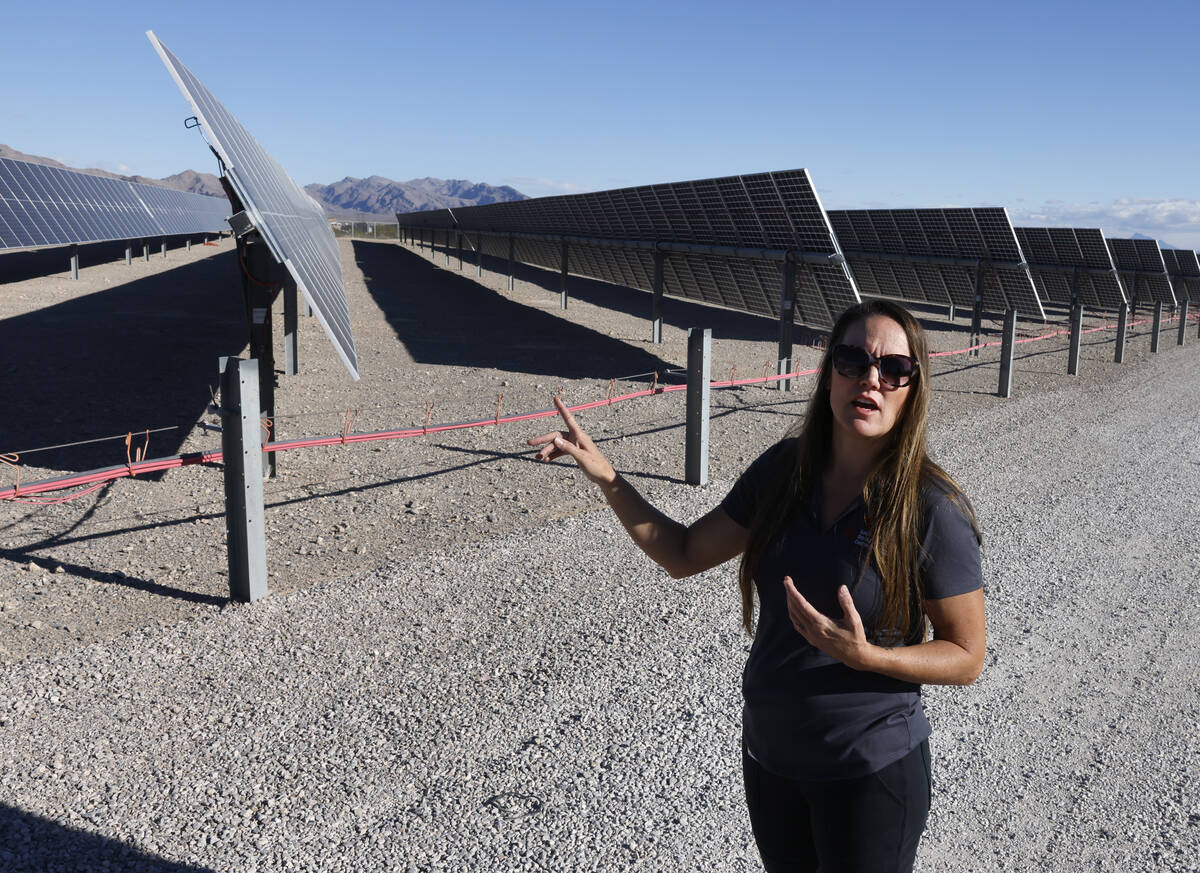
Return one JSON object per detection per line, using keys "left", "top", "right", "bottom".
{"left": 721, "top": 440, "right": 983, "bottom": 779}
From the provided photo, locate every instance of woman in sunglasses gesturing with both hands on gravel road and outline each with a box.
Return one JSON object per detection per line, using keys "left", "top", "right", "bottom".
{"left": 529, "top": 301, "right": 985, "bottom": 873}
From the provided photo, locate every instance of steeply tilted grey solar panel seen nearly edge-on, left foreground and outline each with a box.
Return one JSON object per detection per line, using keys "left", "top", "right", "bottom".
{"left": 146, "top": 31, "right": 359, "bottom": 379}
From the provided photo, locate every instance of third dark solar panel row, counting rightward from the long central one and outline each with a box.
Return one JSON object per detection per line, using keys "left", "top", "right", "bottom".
{"left": 1013, "top": 228, "right": 1128, "bottom": 309}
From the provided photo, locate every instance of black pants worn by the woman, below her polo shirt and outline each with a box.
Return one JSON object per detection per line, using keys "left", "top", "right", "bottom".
{"left": 742, "top": 740, "right": 931, "bottom": 873}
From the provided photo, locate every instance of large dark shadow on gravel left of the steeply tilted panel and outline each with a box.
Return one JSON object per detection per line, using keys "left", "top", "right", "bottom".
{"left": 0, "top": 249, "right": 247, "bottom": 471}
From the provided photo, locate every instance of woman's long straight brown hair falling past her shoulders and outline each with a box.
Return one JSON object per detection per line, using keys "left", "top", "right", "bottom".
{"left": 738, "top": 300, "right": 982, "bottom": 644}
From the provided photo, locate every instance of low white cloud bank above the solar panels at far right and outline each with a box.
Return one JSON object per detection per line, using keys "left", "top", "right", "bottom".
{"left": 1009, "top": 198, "right": 1200, "bottom": 248}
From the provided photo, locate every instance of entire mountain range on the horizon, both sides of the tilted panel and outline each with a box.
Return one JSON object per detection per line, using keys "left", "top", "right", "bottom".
{"left": 0, "top": 144, "right": 526, "bottom": 221}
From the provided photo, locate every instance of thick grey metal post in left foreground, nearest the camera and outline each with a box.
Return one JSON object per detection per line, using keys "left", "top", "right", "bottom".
{"left": 221, "top": 357, "right": 266, "bottom": 603}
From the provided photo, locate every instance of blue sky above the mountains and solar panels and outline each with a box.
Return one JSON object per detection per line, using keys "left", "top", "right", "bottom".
{"left": 0, "top": 0, "right": 1200, "bottom": 248}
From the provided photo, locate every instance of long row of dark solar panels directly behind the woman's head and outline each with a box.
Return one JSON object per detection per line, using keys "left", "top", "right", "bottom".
{"left": 397, "top": 169, "right": 858, "bottom": 326}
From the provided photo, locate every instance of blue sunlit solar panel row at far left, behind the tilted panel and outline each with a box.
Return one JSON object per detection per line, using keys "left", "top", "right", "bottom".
{"left": 0, "top": 158, "right": 229, "bottom": 249}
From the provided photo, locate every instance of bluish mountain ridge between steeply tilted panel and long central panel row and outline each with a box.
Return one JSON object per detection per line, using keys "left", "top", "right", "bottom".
{"left": 305, "top": 176, "right": 527, "bottom": 218}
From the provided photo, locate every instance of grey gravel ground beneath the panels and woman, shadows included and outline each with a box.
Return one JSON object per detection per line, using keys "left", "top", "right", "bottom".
{"left": 0, "top": 235, "right": 1200, "bottom": 872}
